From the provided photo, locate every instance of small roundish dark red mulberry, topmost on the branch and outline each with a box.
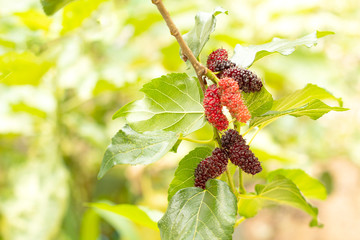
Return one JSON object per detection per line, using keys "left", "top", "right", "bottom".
{"left": 206, "top": 48, "right": 236, "bottom": 72}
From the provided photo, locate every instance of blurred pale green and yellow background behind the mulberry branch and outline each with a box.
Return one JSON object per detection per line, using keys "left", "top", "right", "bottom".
{"left": 0, "top": 0, "right": 360, "bottom": 240}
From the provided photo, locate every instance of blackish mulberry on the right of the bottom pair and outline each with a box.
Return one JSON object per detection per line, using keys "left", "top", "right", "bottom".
{"left": 221, "top": 129, "right": 262, "bottom": 175}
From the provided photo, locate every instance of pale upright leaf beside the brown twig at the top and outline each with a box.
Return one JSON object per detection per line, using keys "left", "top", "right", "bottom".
{"left": 184, "top": 7, "right": 228, "bottom": 57}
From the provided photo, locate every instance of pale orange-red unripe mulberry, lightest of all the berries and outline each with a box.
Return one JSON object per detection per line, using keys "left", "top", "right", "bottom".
{"left": 219, "top": 78, "right": 251, "bottom": 123}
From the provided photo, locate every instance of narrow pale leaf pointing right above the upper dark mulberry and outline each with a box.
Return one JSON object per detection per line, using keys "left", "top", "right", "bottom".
{"left": 231, "top": 31, "right": 334, "bottom": 68}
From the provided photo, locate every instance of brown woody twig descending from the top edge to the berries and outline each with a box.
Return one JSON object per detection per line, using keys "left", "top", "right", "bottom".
{"left": 151, "top": 0, "right": 208, "bottom": 92}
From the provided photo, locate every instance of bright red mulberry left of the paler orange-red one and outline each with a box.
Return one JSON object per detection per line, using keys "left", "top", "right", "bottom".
{"left": 203, "top": 84, "right": 229, "bottom": 131}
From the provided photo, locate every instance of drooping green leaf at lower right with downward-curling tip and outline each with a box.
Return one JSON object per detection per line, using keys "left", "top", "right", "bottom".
{"left": 239, "top": 175, "right": 321, "bottom": 227}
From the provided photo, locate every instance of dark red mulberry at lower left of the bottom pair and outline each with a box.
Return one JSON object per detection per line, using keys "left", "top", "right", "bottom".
{"left": 194, "top": 148, "right": 228, "bottom": 189}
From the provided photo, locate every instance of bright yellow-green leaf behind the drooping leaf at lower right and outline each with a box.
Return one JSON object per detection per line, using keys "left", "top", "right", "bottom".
{"left": 267, "top": 169, "right": 327, "bottom": 200}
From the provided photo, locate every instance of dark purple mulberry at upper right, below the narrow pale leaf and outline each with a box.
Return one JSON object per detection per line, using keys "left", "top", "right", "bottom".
{"left": 220, "top": 66, "right": 263, "bottom": 93}
